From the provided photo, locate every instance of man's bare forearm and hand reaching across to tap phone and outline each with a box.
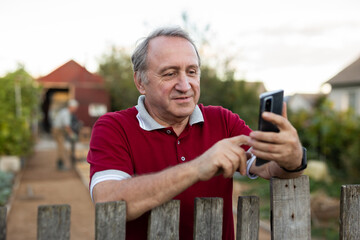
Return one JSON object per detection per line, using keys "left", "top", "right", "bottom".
{"left": 93, "top": 135, "right": 249, "bottom": 220}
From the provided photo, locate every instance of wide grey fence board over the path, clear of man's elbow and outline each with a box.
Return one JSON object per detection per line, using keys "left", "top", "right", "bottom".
{"left": 37, "top": 204, "right": 70, "bottom": 240}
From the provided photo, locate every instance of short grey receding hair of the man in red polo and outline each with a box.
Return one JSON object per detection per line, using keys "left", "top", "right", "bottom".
{"left": 131, "top": 27, "right": 201, "bottom": 83}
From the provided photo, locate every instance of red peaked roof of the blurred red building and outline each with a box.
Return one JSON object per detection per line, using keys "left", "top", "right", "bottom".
{"left": 38, "top": 60, "right": 104, "bottom": 84}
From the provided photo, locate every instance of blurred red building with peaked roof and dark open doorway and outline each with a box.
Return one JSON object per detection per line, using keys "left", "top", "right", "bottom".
{"left": 37, "top": 60, "right": 110, "bottom": 132}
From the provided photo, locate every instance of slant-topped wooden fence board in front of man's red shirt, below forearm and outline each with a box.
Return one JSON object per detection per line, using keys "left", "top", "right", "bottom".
{"left": 148, "top": 200, "right": 180, "bottom": 240}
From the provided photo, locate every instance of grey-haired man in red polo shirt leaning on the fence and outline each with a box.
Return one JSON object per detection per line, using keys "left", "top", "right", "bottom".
{"left": 88, "top": 28, "right": 303, "bottom": 239}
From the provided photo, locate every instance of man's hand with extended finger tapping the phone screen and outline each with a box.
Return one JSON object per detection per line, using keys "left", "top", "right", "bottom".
{"left": 192, "top": 135, "right": 250, "bottom": 181}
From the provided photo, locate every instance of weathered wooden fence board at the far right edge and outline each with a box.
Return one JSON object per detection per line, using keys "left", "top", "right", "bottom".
{"left": 340, "top": 184, "right": 360, "bottom": 240}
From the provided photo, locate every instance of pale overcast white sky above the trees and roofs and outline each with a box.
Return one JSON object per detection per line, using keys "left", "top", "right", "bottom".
{"left": 0, "top": 0, "right": 360, "bottom": 95}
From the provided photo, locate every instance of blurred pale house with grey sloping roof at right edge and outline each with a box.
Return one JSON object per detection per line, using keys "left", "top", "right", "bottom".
{"left": 326, "top": 55, "right": 360, "bottom": 115}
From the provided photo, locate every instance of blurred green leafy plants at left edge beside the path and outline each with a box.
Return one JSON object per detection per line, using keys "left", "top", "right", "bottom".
{"left": 0, "top": 66, "right": 39, "bottom": 155}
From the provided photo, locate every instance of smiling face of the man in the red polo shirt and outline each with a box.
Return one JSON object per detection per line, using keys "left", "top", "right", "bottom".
{"left": 139, "top": 36, "right": 200, "bottom": 126}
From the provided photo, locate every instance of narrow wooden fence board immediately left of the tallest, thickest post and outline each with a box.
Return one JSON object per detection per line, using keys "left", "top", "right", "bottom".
{"left": 236, "top": 196, "right": 260, "bottom": 240}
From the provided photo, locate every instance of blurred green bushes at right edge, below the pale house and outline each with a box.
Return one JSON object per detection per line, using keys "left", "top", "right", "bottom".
{"left": 289, "top": 99, "right": 360, "bottom": 182}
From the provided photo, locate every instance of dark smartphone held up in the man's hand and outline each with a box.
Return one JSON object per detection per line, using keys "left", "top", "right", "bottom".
{"left": 255, "top": 89, "right": 284, "bottom": 166}
